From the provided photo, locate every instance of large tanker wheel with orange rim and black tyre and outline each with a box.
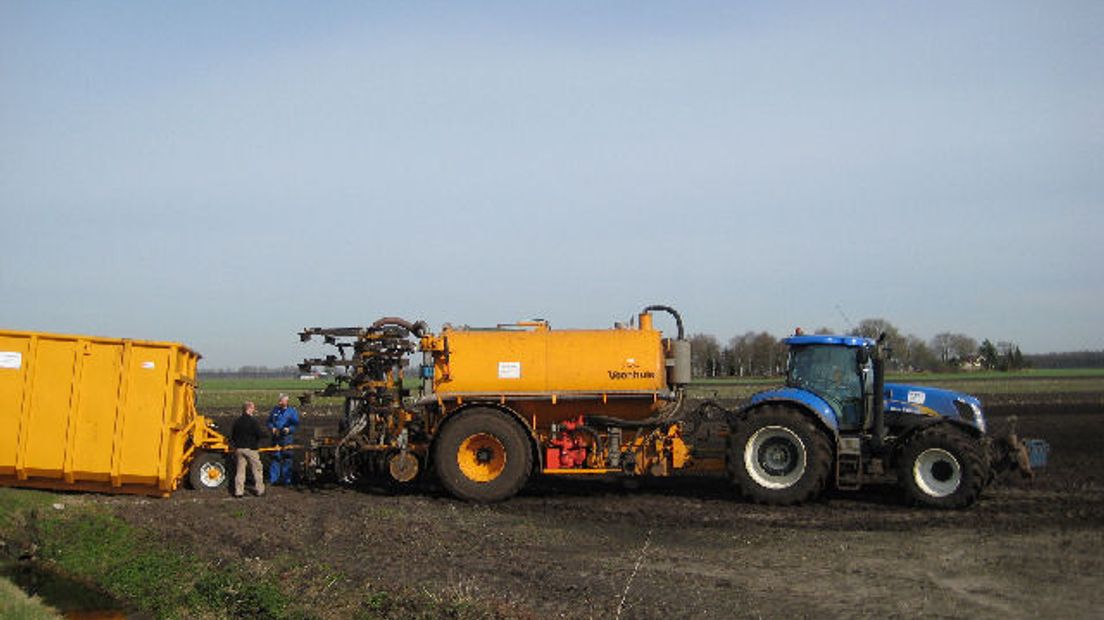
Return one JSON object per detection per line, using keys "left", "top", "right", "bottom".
{"left": 434, "top": 408, "right": 533, "bottom": 502}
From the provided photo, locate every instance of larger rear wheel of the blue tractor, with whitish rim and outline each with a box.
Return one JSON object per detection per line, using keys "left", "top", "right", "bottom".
{"left": 725, "top": 405, "right": 832, "bottom": 505}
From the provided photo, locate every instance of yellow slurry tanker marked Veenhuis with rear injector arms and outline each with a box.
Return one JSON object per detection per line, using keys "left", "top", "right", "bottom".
{"left": 300, "top": 306, "right": 690, "bottom": 501}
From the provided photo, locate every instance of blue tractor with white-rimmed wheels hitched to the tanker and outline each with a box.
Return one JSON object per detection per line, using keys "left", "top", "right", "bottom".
{"left": 725, "top": 333, "right": 1047, "bottom": 509}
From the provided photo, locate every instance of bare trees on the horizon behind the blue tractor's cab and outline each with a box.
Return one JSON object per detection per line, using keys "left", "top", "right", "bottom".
{"left": 690, "top": 319, "right": 1037, "bottom": 377}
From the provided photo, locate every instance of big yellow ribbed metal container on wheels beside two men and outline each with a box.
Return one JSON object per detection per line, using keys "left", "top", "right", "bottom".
{"left": 0, "top": 330, "right": 227, "bottom": 495}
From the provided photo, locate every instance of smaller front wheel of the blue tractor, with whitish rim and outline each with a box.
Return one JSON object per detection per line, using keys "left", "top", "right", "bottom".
{"left": 898, "top": 425, "right": 989, "bottom": 509}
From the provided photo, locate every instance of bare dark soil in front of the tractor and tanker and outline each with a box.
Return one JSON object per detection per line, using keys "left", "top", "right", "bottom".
{"left": 99, "top": 394, "right": 1104, "bottom": 618}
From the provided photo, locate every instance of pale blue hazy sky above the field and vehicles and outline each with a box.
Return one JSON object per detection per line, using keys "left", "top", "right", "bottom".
{"left": 0, "top": 0, "right": 1104, "bottom": 367}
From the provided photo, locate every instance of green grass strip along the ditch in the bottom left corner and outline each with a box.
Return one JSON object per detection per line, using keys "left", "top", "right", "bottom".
{"left": 0, "top": 488, "right": 516, "bottom": 620}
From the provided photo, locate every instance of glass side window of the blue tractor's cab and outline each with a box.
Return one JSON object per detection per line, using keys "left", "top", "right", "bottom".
{"left": 786, "top": 345, "right": 862, "bottom": 428}
